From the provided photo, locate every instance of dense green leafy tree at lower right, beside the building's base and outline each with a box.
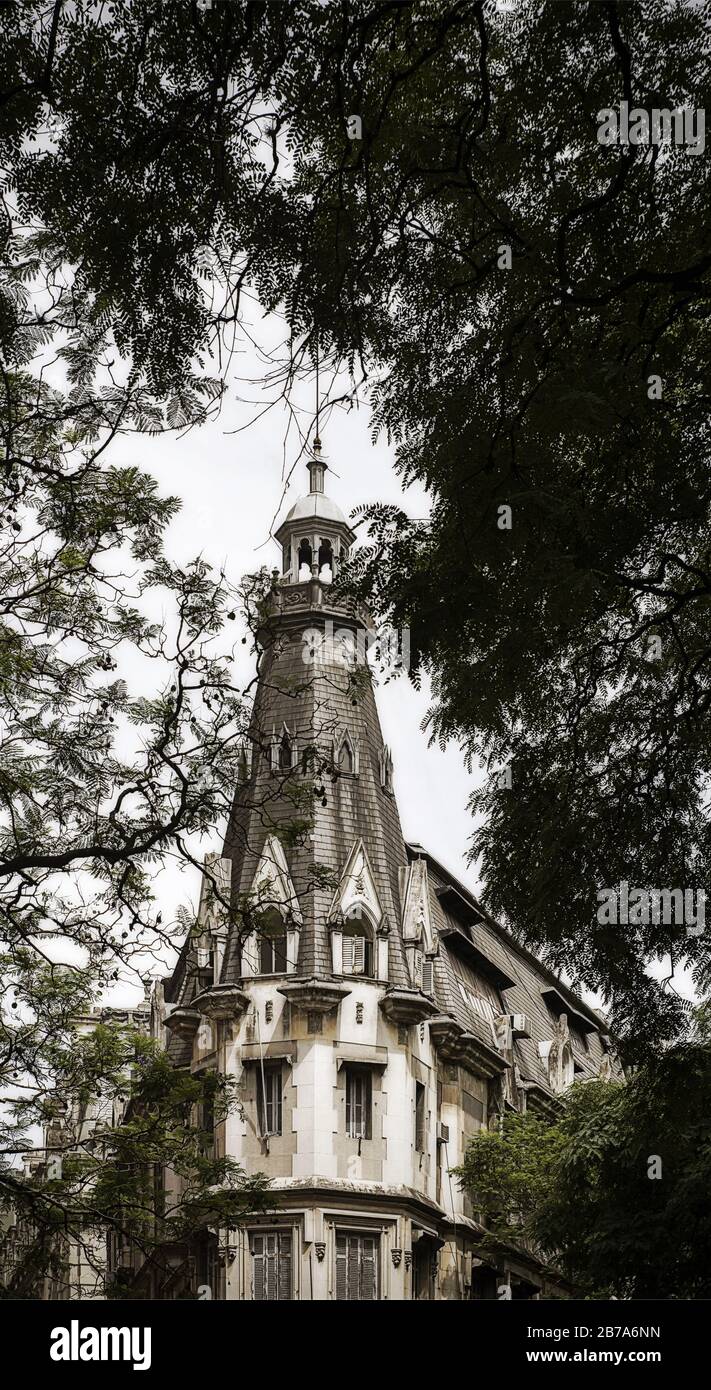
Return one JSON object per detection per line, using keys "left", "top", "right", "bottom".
{"left": 458, "top": 1040, "right": 711, "bottom": 1298}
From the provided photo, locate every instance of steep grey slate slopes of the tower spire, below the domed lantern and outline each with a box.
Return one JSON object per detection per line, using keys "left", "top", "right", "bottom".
{"left": 222, "top": 584, "right": 410, "bottom": 987}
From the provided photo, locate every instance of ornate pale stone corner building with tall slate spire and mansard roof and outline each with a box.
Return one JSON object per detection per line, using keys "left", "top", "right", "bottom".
{"left": 122, "top": 448, "right": 614, "bottom": 1301}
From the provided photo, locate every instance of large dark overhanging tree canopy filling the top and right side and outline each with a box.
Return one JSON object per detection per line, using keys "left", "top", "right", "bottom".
{"left": 0, "top": 0, "right": 711, "bottom": 1051}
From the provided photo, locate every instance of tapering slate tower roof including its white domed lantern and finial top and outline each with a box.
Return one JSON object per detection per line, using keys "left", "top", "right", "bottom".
{"left": 222, "top": 457, "right": 410, "bottom": 988}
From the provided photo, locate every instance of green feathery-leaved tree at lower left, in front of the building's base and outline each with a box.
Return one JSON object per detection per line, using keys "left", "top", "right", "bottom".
{"left": 0, "top": 1017, "right": 268, "bottom": 1298}
